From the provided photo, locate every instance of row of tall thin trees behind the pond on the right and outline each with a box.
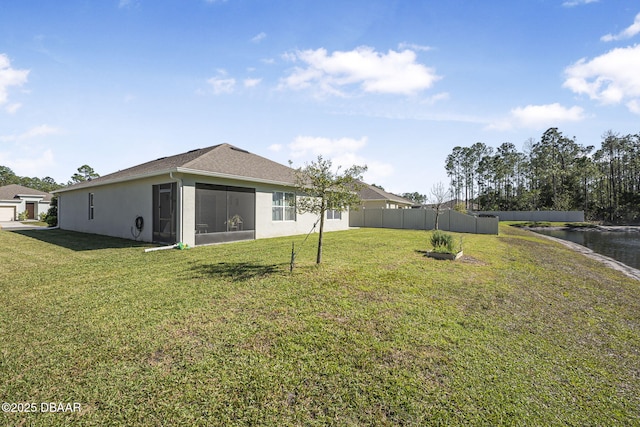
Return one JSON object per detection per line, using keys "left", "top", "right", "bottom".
{"left": 445, "top": 128, "right": 640, "bottom": 222}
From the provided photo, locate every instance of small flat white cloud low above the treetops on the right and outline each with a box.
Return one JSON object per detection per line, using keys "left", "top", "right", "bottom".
{"left": 487, "top": 103, "right": 585, "bottom": 130}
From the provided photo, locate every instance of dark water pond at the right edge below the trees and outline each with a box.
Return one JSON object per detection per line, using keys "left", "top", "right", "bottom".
{"left": 536, "top": 229, "right": 640, "bottom": 269}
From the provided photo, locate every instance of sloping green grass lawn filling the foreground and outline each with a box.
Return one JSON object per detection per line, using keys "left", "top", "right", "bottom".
{"left": 0, "top": 225, "right": 640, "bottom": 426}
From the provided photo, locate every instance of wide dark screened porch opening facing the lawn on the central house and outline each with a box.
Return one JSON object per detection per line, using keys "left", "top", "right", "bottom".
{"left": 195, "top": 184, "right": 256, "bottom": 245}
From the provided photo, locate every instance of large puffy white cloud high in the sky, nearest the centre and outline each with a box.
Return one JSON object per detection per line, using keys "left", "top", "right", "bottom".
{"left": 280, "top": 46, "right": 440, "bottom": 96}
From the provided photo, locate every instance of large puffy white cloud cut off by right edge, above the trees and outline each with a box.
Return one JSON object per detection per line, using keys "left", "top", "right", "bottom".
{"left": 563, "top": 45, "right": 640, "bottom": 111}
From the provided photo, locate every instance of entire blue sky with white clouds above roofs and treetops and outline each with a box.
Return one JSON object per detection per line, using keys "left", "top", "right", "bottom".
{"left": 0, "top": 0, "right": 640, "bottom": 194}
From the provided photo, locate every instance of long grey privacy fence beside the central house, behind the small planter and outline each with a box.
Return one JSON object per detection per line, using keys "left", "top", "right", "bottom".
{"left": 349, "top": 209, "right": 498, "bottom": 234}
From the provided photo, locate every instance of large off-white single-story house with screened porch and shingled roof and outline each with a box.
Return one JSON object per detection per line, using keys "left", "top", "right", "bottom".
{"left": 54, "top": 144, "right": 349, "bottom": 246}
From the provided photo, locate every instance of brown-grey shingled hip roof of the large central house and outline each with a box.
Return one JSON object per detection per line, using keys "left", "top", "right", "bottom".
{"left": 55, "top": 144, "right": 295, "bottom": 192}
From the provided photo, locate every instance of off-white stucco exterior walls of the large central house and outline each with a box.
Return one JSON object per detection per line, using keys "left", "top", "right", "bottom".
{"left": 58, "top": 174, "right": 349, "bottom": 246}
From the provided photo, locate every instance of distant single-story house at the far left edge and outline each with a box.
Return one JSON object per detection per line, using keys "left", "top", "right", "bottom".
{"left": 0, "top": 184, "right": 52, "bottom": 221}
